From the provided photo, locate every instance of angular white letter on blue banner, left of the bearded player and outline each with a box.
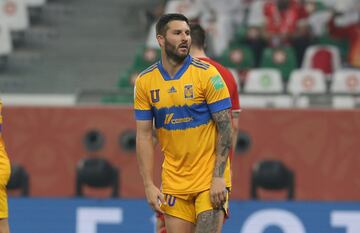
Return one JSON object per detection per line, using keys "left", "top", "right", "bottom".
{"left": 76, "top": 207, "right": 123, "bottom": 233}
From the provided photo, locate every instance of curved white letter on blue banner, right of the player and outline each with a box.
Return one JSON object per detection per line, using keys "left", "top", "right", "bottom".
{"left": 240, "top": 209, "right": 306, "bottom": 233}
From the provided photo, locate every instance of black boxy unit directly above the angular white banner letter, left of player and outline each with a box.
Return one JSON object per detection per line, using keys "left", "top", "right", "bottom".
{"left": 76, "top": 157, "right": 119, "bottom": 198}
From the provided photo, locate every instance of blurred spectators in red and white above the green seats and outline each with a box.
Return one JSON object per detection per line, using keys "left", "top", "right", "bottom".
{"left": 146, "top": 0, "right": 360, "bottom": 67}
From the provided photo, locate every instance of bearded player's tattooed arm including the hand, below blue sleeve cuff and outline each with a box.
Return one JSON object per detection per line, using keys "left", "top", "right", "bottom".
{"left": 210, "top": 109, "right": 232, "bottom": 208}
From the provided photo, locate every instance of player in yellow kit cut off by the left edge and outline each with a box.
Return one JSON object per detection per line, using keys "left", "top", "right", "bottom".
{"left": 0, "top": 100, "right": 10, "bottom": 233}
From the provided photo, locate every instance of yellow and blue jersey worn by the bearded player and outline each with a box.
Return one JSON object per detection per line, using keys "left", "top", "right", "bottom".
{"left": 134, "top": 55, "right": 231, "bottom": 194}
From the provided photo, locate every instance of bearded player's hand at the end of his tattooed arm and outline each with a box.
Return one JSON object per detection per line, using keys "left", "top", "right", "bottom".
{"left": 210, "top": 177, "right": 228, "bottom": 208}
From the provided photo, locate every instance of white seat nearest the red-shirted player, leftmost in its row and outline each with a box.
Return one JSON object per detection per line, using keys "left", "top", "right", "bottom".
{"left": 244, "top": 69, "right": 284, "bottom": 94}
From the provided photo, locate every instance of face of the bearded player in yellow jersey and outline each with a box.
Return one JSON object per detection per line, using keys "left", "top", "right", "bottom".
{"left": 162, "top": 20, "right": 191, "bottom": 63}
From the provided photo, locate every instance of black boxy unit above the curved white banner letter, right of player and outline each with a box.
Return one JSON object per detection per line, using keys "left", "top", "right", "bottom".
{"left": 250, "top": 160, "right": 295, "bottom": 200}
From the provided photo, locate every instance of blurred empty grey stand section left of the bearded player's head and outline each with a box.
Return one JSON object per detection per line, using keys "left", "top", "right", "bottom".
{"left": 0, "top": 0, "right": 152, "bottom": 96}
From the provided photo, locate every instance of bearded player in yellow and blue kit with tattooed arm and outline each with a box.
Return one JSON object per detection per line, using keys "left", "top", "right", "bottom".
{"left": 134, "top": 14, "right": 232, "bottom": 233}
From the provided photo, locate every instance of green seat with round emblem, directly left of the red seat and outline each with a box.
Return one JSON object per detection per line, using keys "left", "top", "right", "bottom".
{"left": 260, "top": 47, "right": 297, "bottom": 82}
